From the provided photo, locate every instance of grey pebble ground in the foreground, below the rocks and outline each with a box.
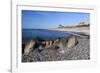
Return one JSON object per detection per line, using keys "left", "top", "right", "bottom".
{"left": 22, "top": 38, "right": 90, "bottom": 62}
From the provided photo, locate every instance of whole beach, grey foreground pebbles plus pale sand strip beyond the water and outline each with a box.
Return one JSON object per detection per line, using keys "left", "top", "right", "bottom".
{"left": 22, "top": 27, "right": 90, "bottom": 63}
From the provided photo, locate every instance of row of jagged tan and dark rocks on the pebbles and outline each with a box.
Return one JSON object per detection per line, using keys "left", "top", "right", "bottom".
{"left": 24, "top": 36, "right": 78, "bottom": 55}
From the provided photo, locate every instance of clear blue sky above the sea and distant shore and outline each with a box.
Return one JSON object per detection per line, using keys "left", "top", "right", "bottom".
{"left": 22, "top": 10, "right": 90, "bottom": 29}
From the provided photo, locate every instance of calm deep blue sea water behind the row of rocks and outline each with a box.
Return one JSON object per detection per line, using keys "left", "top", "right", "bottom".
{"left": 22, "top": 29, "right": 71, "bottom": 41}
